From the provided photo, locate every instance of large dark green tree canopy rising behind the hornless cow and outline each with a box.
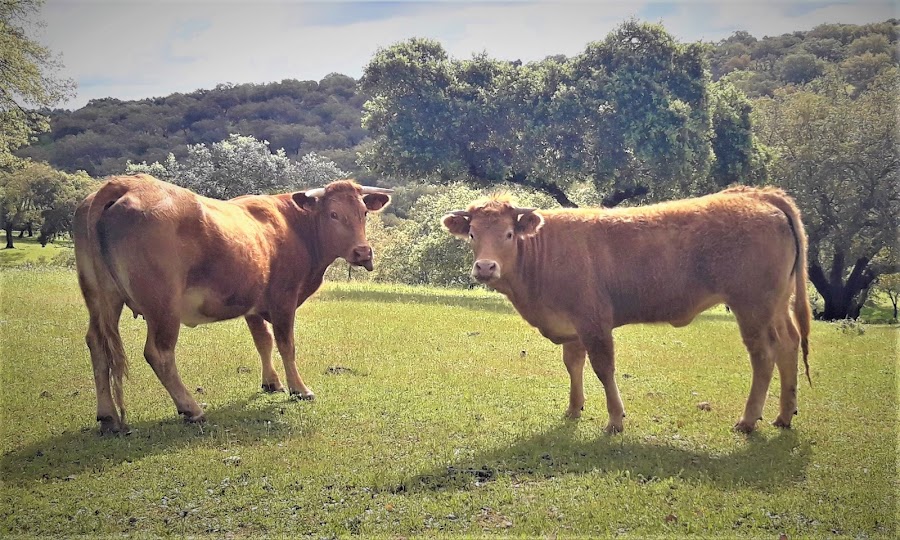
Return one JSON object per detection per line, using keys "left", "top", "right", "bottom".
{"left": 361, "top": 21, "right": 752, "bottom": 206}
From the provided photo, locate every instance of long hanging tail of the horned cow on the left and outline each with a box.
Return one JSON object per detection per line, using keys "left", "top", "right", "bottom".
{"left": 75, "top": 181, "right": 129, "bottom": 424}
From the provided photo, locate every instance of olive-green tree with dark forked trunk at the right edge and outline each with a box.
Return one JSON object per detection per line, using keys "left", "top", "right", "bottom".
{"left": 756, "top": 68, "right": 900, "bottom": 320}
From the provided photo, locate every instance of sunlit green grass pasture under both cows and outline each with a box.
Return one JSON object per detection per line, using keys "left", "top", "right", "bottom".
{"left": 0, "top": 269, "right": 900, "bottom": 538}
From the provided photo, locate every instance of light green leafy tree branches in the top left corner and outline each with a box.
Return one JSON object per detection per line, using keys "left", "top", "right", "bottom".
{"left": 0, "top": 0, "right": 75, "bottom": 170}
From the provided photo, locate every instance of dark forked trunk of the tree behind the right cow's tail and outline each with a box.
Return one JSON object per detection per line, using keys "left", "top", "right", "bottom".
{"left": 809, "top": 253, "right": 875, "bottom": 321}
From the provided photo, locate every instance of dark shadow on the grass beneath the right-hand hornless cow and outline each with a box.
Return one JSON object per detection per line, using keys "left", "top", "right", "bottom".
{"left": 390, "top": 422, "right": 812, "bottom": 493}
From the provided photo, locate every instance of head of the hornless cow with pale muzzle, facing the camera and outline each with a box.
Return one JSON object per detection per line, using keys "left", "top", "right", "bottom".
{"left": 442, "top": 195, "right": 544, "bottom": 284}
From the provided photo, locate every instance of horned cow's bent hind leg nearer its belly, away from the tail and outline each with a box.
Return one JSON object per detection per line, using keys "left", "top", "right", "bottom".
{"left": 144, "top": 316, "right": 204, "bottom": 422}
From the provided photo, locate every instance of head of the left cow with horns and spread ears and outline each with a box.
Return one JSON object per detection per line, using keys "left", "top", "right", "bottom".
{"left": 291, "top": 180, "right": 391, "bottom": 271}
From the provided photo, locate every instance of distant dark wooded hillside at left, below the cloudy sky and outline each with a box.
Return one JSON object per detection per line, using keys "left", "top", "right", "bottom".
{"left": 21, "top": 73, "right": 366, "bottom": 176}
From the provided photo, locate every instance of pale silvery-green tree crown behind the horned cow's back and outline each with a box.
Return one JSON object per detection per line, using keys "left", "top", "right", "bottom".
{"left": 126, "top": 135, "right": 347, "bottom": 199}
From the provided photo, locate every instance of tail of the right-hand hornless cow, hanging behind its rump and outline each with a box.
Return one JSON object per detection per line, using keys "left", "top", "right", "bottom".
{"left": 758, "top": 188, "right": 812, "bottom": 386}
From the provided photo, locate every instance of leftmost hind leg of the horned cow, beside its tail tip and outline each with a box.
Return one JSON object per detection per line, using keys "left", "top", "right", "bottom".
{"left": 85, "top": 291, "right": 128, "bottom": 433}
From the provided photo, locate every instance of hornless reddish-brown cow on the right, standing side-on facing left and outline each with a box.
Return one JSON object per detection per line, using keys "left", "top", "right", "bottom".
{"left": 443, "top": 187, "right": 810, "bottom": 433}
